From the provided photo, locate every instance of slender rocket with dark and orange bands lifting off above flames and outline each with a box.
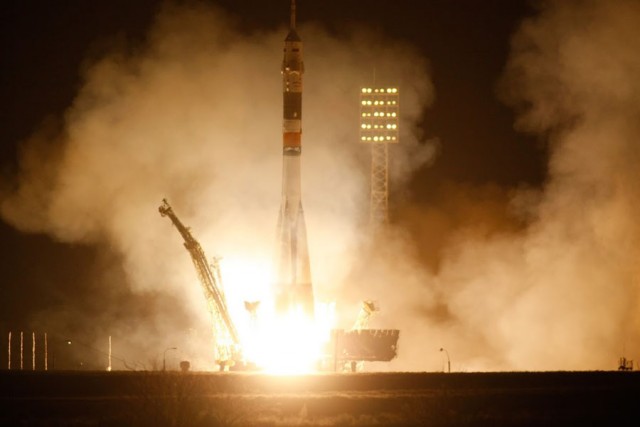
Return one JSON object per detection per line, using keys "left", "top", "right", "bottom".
{"left": 276, "top": 0, "right": 314, "bottom": 317}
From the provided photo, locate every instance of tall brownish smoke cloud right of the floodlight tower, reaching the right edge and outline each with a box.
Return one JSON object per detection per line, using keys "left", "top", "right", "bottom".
{"left": 370, "top": 0, "right": 640, "bottom": 370}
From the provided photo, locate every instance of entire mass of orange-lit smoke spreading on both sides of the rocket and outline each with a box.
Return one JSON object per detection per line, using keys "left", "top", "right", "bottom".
{"left": 2, "top": 0, "right": 640, "bottom": 371}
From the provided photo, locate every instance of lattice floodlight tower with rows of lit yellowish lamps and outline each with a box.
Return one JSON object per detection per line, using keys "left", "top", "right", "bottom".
{"left": 360, "top": 87, "right": 400, "bottom": 230}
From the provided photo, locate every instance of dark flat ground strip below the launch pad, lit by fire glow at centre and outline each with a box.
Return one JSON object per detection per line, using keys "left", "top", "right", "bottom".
{"left": 0, "top": 371, "right": 640, "bottom": 427}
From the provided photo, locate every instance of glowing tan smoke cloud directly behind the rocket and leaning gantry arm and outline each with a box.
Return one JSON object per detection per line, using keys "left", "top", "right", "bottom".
{"left": 2, "top": 3, "right": 432, "bottom": 367}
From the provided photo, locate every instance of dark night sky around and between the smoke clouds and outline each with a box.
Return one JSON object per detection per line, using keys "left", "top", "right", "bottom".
{"left": 0, "top": 0, "right": 545, "bottom": 329}
